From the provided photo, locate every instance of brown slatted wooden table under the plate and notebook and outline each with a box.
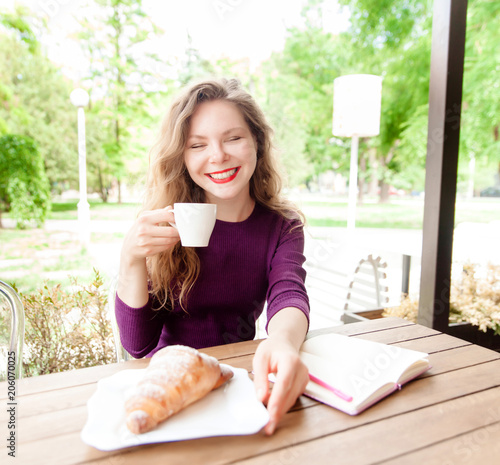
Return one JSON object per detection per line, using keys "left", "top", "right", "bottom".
{"left": 0, "top": 318, "right": 500, "bottom": 465}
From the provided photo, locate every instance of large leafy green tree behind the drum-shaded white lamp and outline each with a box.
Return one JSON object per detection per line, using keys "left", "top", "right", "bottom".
{"left": 260, "top": 0, "right": 436, "bottom": 201}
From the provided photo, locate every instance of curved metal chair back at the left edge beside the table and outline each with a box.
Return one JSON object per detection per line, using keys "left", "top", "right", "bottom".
{"left": 0, "top": 281, "right": 24, "bottom": 379}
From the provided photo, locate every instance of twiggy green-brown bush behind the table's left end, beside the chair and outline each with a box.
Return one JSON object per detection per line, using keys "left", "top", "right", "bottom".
{"left": 0, "top": 270, "right": 116, "bottom": 377}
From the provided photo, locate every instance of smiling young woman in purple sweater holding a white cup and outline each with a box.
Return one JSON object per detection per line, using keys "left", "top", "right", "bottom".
{"left": 116, "top": 79, "right": 309, "bottom": 434}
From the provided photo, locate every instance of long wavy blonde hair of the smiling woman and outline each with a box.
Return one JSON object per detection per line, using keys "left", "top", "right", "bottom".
{"left": 143, "top": 79, "right": 303, "bottom": 310}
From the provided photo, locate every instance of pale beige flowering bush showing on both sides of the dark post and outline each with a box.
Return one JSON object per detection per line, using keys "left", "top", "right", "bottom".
{"left": 383, "top": 263, "right": 500, "bottom": 334}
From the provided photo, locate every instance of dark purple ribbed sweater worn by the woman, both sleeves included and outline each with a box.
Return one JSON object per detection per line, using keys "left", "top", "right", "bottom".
{"left": 115, "top": 204, "right": 309, "bottom": 358}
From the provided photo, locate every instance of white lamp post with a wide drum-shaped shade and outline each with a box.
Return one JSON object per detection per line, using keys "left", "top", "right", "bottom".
{"left": 332, "top": 74, "right": 382, "bottom": 230}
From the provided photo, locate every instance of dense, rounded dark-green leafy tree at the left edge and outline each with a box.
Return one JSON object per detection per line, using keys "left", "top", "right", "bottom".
{"left": 0, "top": 134, "right": 50, "bottom": 229}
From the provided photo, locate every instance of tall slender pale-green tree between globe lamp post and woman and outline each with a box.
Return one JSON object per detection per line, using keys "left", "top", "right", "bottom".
{"left": 78, "top": 0, "right": 164, "bottom": 202}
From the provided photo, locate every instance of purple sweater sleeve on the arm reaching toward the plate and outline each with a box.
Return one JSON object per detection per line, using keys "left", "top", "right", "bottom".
{"left": 266, "top": 221, "right": 309, "bottom": 330}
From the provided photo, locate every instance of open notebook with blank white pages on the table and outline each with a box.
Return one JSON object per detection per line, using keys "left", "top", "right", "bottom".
{"left": 300, "top": 334, "right": 430, "bottom": 415}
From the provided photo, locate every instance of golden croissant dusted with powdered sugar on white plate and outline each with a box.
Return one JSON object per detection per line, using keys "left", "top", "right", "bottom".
{"left": 125, "top": 345, "right": 233, "bottom": 434}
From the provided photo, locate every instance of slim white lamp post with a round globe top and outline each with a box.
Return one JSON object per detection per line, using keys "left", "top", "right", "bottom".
{"left": 70, "top": 89, "right": 90, "bottom": 247}
